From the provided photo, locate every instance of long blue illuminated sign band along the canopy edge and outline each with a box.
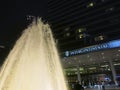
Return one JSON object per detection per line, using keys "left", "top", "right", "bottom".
{"left": 64, "top": 40, "right": 120, "bottom": 57}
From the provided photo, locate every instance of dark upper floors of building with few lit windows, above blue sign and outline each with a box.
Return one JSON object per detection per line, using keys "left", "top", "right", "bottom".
{"left": 47, "top": 0, "right": 120, "bottom": 52}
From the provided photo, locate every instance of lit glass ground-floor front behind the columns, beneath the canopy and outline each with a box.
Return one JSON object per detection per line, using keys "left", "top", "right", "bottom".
{"left": 64, "top": 61, "right": 120, "bottom": 85}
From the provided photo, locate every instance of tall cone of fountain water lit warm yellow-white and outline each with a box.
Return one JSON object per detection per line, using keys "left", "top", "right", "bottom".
{"left": 0, "top": 19, "right": 68, "bottom": 90}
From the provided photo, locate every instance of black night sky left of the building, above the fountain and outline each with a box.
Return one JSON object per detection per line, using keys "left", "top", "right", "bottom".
{"left": 0, "top": 0, "right": 47, "bottom": 63}
